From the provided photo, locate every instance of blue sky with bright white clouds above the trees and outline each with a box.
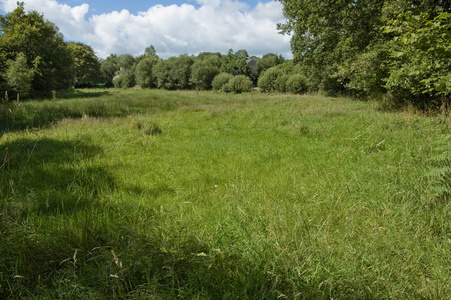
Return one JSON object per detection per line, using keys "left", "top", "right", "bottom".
{"left": 0, "top": 0, "right": 292, "bottom": 58}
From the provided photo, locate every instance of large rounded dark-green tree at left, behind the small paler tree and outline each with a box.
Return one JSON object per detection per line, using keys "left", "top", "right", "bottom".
{"left": 0, "top": 2, "right": 74, "bottom": 94}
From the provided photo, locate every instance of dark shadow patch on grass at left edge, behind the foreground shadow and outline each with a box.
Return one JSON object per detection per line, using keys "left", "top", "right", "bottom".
{"left": 0, "top": 139, "right": 114, "bottom": 216}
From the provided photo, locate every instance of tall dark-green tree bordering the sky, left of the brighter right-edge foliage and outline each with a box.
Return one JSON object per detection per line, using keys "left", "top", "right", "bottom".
{"left": 279, "top": 0, "right": 385, "bottom": 93}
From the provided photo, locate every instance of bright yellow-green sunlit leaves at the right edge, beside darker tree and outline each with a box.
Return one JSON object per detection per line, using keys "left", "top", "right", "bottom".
{"left": 384, "top": 11, "right": 451, "bottom": 102}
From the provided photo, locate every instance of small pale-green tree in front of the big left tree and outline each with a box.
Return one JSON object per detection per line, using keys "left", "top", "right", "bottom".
{"left": 6, "top": 53, "right": 34, "bottom": 100}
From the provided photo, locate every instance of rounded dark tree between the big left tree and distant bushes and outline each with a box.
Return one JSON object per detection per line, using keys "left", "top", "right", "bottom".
{"left": 68, "top": 43, "right": 101, "bottom": 88}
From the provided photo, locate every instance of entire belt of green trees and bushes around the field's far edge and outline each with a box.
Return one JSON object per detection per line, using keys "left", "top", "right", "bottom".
{"left": 0, "top": 0, "right": 451, "bottom": 106}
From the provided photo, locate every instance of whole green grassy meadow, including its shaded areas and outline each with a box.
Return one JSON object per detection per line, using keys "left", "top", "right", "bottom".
{"left": 0, "top": 90, "right": 451, "bottom": 299}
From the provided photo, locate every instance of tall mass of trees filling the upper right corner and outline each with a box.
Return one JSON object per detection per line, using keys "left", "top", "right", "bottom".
{"left": 279, "top": 0, "right": 451, "bottom": 106}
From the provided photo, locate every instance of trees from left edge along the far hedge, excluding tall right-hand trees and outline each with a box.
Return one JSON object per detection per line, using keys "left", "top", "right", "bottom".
{"left": 0, "top": 2, "right": 300, "bottom": 97}
